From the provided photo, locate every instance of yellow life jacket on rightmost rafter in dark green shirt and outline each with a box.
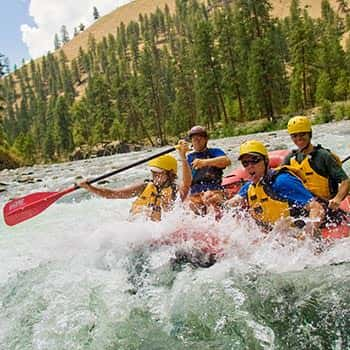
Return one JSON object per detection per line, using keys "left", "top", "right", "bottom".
{"left": 290, "top": 145, "right": 342, "bottom": 200}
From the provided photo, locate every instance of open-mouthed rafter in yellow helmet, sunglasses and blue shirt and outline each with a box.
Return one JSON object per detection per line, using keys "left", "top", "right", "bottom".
{"left": 227, "top": 140, "right": 324, "bottom": 233}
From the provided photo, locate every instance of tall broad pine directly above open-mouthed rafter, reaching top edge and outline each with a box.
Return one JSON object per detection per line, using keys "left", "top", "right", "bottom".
{"left": 235, "top": 0, "right": 286, "bottom": 121}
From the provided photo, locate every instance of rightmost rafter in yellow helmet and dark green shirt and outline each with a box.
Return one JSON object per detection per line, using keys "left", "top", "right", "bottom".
{"left": 283, "top": 116, "right": 350, "bottom": 210}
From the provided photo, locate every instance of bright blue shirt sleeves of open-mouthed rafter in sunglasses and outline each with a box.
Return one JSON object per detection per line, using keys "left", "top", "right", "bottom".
{"left": 238, "top": 173, "right": 314, "bottom": 207}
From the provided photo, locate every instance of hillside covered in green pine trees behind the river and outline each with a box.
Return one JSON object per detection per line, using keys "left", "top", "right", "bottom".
{"left": 2, "top": 0, "right": 350, "bottom": 163}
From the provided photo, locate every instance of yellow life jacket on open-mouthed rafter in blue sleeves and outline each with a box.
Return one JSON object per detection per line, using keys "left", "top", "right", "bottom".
{"left": 247, "top": 166, "right": 307, "bottom": 228}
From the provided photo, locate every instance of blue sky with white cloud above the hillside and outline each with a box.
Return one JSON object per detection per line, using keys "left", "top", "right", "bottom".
{"left": 0, "top": 0, "right": 131, "bottom": 70}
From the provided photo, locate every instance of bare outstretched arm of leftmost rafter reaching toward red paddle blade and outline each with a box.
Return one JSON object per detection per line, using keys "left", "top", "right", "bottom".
{"left": 78, "top": 181, "right": 146, "bottom": 199}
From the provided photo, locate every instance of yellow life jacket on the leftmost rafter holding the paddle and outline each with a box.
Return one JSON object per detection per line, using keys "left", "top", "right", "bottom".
{"left": 131, "top": 181, "right": 177, "bottom": 221}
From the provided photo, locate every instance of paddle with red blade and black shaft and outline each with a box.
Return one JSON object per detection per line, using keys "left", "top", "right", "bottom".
{"left": 3, "top": 147, "right": 175, "bottom": 226}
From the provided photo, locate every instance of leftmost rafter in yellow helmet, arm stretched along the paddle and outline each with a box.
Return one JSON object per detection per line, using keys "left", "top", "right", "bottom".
{"left": 79, "top": 154, "right": 182, "bottom": 221}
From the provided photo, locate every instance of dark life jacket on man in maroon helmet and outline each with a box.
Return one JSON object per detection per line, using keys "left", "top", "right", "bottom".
{"left": 191, "top": 148, "right": 223, "bottom": 189}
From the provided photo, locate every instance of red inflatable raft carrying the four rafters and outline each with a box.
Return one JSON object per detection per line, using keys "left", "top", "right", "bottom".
{"left": 222, "top": 150, "right": 350, "bottom": 239}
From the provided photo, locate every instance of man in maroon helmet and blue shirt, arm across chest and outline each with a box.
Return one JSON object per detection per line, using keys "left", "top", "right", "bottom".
{"left": 178, "top": 125, "right": 231, "bottom": 217}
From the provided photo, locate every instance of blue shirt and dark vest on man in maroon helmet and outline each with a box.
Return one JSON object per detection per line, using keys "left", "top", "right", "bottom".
{"left": 187, "top": 148, "right": 226, "bottom": 194}
